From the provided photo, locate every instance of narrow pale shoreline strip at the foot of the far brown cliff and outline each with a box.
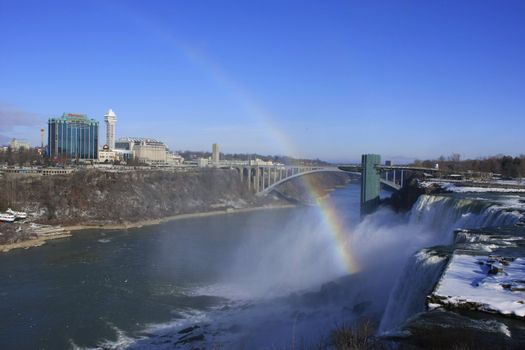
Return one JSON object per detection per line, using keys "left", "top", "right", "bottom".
{"left": 0, "top": 204, "right": 297, "bottom": 253}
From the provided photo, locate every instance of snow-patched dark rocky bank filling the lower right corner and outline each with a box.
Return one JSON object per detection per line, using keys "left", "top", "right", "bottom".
{"left": 385, "top": 223, "right": 525, "bottom": 349}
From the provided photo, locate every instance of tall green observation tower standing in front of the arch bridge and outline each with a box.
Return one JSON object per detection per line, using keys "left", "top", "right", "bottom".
{"left": 361, "top": 154, "right": 381, "bottom": 216}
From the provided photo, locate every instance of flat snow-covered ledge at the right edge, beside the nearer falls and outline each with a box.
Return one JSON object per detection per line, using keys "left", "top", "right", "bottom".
{"left": 429, "top": 254, "right": 525, "bottom": 317}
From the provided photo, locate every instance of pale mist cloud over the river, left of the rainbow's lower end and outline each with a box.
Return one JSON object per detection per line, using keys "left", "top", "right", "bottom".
{"left": 219, "top": 208, "right": 347, "bottom": 298}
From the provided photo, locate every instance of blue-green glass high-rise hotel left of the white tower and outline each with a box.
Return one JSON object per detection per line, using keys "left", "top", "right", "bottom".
{"left": 48, "top": 113, "right": 98, "bottom": 159}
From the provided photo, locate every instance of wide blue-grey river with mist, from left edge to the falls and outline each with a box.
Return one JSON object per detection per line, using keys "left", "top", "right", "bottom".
{"left": 0, "top": 184, "right": 517, "bottom": 349}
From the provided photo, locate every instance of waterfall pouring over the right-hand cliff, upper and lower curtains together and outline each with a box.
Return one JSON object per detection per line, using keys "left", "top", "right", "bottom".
{"left": 379, "top": 195, "right": 523, "bottom": 334}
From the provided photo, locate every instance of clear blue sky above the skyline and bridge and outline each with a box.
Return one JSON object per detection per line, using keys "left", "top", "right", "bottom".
{"left": 0, "top": 0, "right": 525, "bottom": 161}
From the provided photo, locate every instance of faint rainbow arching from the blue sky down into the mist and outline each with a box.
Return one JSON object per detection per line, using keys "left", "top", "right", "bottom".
{"left": 116, "top": 4, "right": 359, "bottom": 274}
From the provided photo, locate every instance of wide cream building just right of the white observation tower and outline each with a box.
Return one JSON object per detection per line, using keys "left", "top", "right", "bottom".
{"left": 115, "top": 137, "right": 167, "bottom": 164}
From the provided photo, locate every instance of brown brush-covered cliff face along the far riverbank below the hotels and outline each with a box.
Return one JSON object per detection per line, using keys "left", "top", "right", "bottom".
{"left": 0, "top": 169, "right": 348, "bottom": 224}
